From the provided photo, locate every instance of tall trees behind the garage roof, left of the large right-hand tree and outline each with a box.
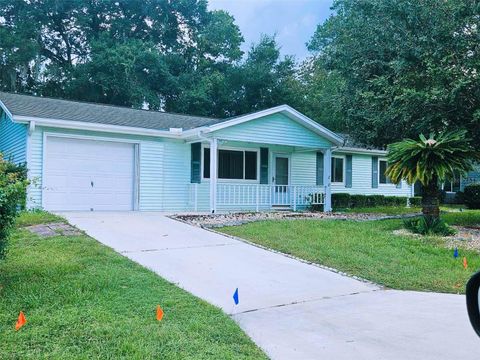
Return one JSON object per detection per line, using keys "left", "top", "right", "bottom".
{"left": 0, "top": 0, "right": 304, "bottom": 117}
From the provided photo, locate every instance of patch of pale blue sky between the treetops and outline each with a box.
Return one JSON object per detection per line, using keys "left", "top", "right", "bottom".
{"left": 209, "top": 0, "right": 333, "bottom": 60}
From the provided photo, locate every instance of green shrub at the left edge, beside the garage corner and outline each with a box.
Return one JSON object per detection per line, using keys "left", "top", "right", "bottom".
{"left": 0, "top": 154, "right": 28, "bottom": 259}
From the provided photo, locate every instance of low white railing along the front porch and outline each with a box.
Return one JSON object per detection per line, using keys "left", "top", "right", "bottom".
{"left": 189, "top": 183, "right": 325, "bottom": 211}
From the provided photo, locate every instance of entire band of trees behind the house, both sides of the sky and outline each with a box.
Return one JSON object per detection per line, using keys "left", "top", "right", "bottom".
{"left": 0, "top": 0, "right": 480, "bottom": 147}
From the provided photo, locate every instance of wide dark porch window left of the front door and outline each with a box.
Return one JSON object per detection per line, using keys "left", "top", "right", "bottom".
{"left": 203, "top": 148, "right": 258, "bottom": 180}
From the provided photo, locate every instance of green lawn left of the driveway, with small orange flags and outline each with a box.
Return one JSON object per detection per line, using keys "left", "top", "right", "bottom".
{"left": 0, "top": 213, "right": 266, "bottom": 359}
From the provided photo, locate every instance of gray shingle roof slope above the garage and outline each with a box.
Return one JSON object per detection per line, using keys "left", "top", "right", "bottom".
{"left": 0, "top": 92, "right": 225, "bottom": 130}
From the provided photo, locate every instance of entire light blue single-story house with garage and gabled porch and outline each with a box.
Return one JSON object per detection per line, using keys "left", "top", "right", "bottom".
{"left": 0, "top": 92, "right": 412, "bottom": 212}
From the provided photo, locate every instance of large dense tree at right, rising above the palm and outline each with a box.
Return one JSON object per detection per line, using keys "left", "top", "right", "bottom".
{"left": 309, "top": 0, "right": 480, "bottom": 146}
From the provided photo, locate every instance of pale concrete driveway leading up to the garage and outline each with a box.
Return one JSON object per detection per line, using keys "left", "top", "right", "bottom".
{"left": 62, "top": 212, "right": 480, "bottom": 360}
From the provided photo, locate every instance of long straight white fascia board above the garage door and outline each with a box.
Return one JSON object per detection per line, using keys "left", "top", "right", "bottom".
{"left": 13, "top": 116, "right": 182, "bottom": 139}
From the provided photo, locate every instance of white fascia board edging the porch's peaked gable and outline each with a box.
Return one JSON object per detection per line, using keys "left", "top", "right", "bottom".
{"left": 209, "top": 105, "right": 343, "bottom": 145}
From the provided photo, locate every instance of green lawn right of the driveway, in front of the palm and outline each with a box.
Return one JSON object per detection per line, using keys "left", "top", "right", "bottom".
{"left": 220, "top": 211, "right": 480, "bottom": 293}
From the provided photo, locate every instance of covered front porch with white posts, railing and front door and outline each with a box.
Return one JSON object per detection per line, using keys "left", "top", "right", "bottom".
{"left": 187, "top": 138, "right": 332, "bottom": 213}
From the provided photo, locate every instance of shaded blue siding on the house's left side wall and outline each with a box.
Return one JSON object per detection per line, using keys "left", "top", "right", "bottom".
{"left": 0, "top": 111, "right": 27, "bottom": 163}
